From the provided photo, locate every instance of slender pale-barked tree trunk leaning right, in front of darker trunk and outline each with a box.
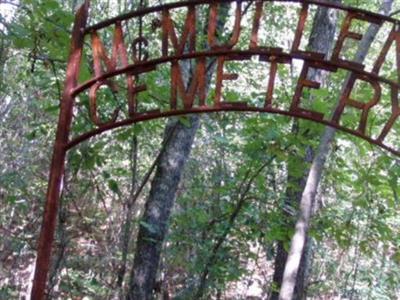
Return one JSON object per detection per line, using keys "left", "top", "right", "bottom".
{"left": 279, "top": 0, "right": 393, "bottom": 300}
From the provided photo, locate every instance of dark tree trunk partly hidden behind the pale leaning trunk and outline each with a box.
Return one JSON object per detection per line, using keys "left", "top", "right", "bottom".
{"left": 270, "top": 0, "right": 341, "bottom": 300}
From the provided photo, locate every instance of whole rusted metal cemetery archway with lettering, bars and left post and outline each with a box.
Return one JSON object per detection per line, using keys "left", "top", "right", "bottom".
{"left": 31, "top": 0, "right": 400, "bottom": 300}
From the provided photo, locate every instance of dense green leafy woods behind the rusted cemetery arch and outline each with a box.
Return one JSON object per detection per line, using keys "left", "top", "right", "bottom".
{"left": 0, "top": 0, "right": 400, "bottom": 299}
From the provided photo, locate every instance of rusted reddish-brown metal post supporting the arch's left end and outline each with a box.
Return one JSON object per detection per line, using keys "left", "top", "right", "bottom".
{"left": 31, "top": 0, "right": 89, "bottom": 300}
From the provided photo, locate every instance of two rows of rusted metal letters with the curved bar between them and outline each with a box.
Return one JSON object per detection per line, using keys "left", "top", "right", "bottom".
{"left": 74, "top": 1, "right": 400, "bottom": 152}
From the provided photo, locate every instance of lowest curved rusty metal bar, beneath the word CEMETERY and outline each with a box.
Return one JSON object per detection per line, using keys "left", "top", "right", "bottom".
{"left": 66, "top": 106, "right": 400, "bottom": 156}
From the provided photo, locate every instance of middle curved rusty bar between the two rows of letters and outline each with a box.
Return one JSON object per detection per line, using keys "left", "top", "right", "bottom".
{"left": 72, "top": 48, "right": 400, "bottom": 97}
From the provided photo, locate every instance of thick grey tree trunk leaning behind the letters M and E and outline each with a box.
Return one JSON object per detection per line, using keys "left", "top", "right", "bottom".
{"left": 127, "top": 4, "right": 230, "bottom": 300}
